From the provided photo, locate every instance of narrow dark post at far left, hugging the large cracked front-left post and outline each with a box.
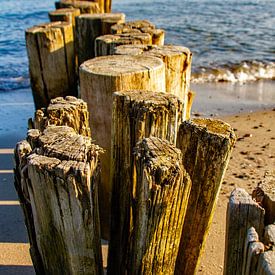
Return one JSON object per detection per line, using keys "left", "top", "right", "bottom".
{"left": 14, "top": 140, "right": 45, "bottom": 275}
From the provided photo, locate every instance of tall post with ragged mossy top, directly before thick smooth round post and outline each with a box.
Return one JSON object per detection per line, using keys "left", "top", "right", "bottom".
{"left": 108, "top": 91, "right": 183, "bottom": 274}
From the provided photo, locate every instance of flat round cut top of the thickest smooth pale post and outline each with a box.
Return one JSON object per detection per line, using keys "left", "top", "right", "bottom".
{"left": 80, "top": 55, "right": 164, "bottom": 76}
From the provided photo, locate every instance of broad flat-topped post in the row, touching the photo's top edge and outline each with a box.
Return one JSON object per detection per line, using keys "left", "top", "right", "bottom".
{"left": 59, "top": 0, "right": 100, "bottom": 14}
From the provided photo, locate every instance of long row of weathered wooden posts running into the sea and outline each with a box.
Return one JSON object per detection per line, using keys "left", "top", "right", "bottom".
{"left": 15, "top": 0, "right": 274, "bottom": 274}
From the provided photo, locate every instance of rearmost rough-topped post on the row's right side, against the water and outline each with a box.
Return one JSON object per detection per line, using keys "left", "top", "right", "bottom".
{"left": 111, "top": 20, "right": 165, "bottom": 46}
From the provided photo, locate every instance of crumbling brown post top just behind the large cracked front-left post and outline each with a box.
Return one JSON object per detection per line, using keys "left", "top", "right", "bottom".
{"left": 32, "top": 96, "right": 91, "bottom": 137}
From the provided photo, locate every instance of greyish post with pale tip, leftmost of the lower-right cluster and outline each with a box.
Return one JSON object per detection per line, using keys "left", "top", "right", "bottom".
{"left": 224, "top": 188, "right": 265, "bottom": 275}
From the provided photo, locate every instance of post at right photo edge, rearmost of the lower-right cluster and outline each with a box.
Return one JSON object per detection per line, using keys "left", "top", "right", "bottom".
{"left": 252, "top": 170, "right": 275, "bottom": 225}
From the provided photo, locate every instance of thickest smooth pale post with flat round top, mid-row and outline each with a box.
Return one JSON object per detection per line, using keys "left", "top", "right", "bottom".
{"left": 80, "top": 55, "right": 165, "bottom": 238}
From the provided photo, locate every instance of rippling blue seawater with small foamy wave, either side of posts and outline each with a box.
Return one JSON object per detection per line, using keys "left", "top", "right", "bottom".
{"left": 0, "top": 0, "right": 275, "bottom": 91}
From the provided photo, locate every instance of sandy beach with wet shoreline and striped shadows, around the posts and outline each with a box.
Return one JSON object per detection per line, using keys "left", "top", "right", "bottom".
{"left": 0, "top": 81, "right": 275, "bottom": 275}
